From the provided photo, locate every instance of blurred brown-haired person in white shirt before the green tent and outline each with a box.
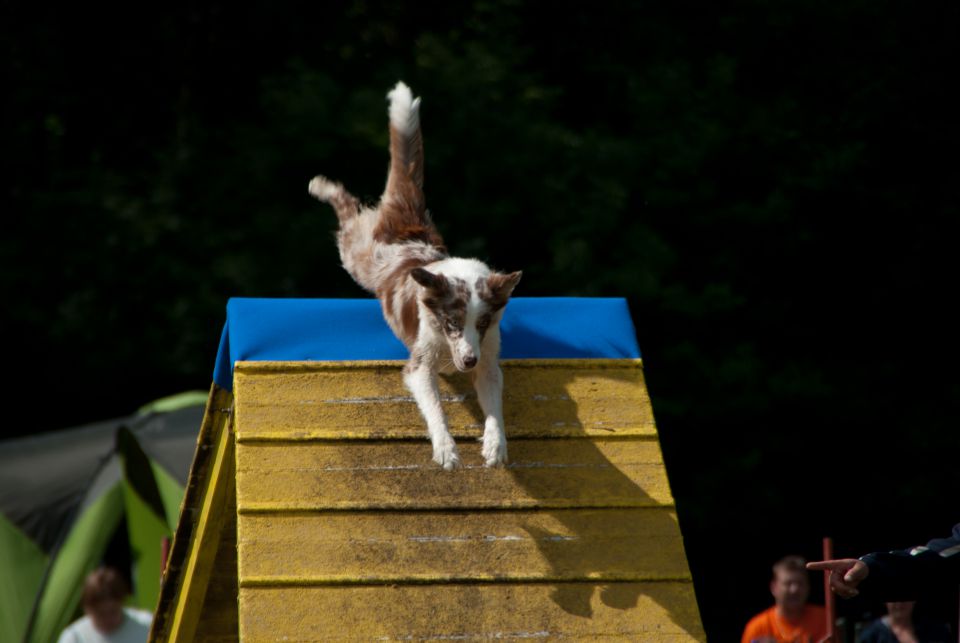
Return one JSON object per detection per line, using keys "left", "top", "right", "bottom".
{"left": 57, "top": 567, "right": 152, "bottom": 643}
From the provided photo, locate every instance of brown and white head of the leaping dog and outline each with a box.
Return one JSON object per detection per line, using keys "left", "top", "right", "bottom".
{"left": 410, "top": 268, "right": 523, "bottom": 372}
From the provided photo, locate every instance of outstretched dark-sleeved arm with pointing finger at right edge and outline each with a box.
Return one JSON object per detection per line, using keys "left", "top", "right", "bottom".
{"left": 807, "top": 523, "right": 960, "bottom": 601}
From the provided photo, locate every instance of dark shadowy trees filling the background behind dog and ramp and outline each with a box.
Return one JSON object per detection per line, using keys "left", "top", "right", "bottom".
{"left": 0, "top": 0, "right": 960, "bottom": 641}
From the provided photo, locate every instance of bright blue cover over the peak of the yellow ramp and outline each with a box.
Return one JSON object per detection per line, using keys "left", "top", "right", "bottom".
{"left": 213, "top": 297, "right": 640, "bottom": 390}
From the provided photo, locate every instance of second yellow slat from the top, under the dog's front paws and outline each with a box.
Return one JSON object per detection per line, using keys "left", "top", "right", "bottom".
{"left": 237, "top": 438, "right": 673, "bottom": 512}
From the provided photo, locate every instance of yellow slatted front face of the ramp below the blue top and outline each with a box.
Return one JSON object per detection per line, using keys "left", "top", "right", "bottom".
{"left": 232, "top": 359, "right": 705, "bottom": 642}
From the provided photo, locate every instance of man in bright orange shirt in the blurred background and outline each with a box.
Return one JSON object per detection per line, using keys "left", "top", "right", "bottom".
{"left": 740, "top": 556, "right": 827, "bottom": 643}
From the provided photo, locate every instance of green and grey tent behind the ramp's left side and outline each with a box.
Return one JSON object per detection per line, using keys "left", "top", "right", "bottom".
{"left": 0, "top": 393, "right": 207, "bottom": 643}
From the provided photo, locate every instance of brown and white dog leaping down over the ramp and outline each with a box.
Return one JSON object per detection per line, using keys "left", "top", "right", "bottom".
{"left": 309, "top": 82, "right": 521, "bottom": 470}
